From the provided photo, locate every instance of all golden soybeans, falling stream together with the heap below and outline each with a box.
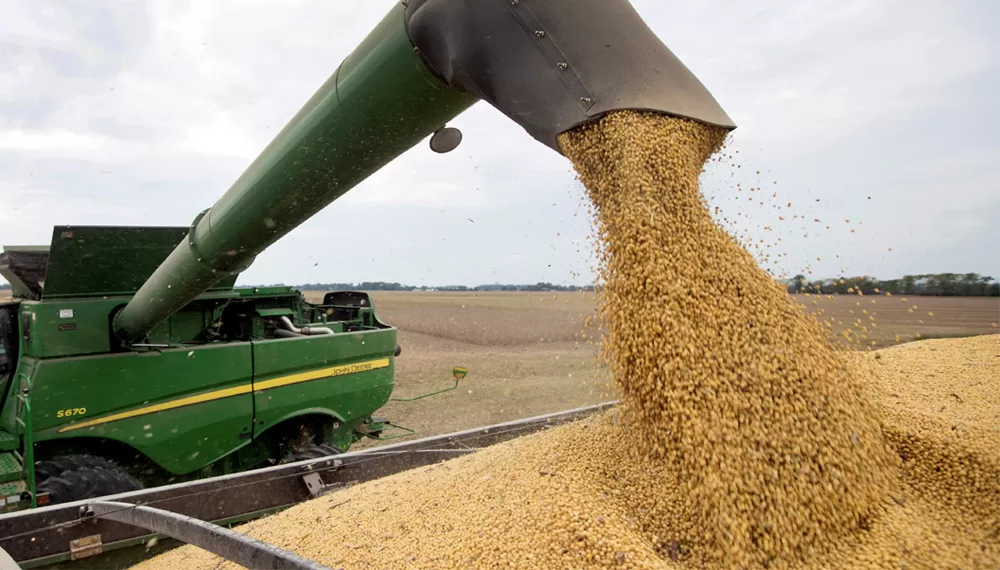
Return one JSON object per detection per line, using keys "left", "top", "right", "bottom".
{"left": 139, "top": 111, "right": 1000, "bottom": 570}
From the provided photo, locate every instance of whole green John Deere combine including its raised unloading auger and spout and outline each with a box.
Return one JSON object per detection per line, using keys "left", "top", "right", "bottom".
{"left": 0, "top": 0, "right": 733, "bottom": 509}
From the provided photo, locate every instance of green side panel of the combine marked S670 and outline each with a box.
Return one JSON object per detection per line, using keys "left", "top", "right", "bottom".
{"left": 30, "top": 343, "right": 253, "bottom": 474}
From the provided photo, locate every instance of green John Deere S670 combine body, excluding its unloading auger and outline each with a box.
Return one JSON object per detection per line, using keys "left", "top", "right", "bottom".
{"left": 0, "top": 226, "right": 418, "bottom": 509}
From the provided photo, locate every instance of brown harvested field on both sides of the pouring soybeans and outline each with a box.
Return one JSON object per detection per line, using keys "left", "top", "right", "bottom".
{"left": 307, "top": 292, "right": 1000, "bottom": 444}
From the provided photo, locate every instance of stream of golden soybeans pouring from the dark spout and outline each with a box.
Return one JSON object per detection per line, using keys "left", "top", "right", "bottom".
{"left": 561, "top": 112, "right": 898, "bottom": 568}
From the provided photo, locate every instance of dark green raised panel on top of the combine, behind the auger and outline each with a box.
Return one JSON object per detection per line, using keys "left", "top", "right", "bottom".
{"left": 43, "top": 226, "right": 236, "bottom": 299}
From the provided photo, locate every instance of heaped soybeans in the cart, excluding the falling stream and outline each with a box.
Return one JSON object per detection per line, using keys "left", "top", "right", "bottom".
{"left": 137, "top": 335, "right": 1000, "bottom": 570}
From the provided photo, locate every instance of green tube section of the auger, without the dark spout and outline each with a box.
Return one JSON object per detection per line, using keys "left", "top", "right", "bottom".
{"left": 115, "top": 4, "right": 476, "bottom": 340}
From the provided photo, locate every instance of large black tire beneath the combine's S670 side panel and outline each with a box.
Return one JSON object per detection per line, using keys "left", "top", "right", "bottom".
{"left": 35, "top": 455, "right": 142, "bottom": 505}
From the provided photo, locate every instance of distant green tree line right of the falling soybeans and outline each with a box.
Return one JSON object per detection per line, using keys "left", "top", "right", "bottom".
{"left": 788, "top": 273, "right": 1000, "bottom": 297}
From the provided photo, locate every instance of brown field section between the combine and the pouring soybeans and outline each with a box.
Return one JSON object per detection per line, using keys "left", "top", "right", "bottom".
{"left": 338, "top": 293, "right": 613, "bottom": 442}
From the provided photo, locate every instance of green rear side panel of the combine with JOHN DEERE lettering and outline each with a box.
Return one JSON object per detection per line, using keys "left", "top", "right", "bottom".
{"left": 254, "top": 329, "right": 396, "bottom": 435}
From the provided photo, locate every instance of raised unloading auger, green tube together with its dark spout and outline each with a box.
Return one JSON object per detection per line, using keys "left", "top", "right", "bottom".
{"left": 114, "top": 0, "right": 735, "bottom": 344}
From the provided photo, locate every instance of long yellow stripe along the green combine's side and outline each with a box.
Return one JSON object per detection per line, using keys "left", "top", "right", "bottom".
{"left": 53, "top": 358, "right": 389, "bottom": 433}
